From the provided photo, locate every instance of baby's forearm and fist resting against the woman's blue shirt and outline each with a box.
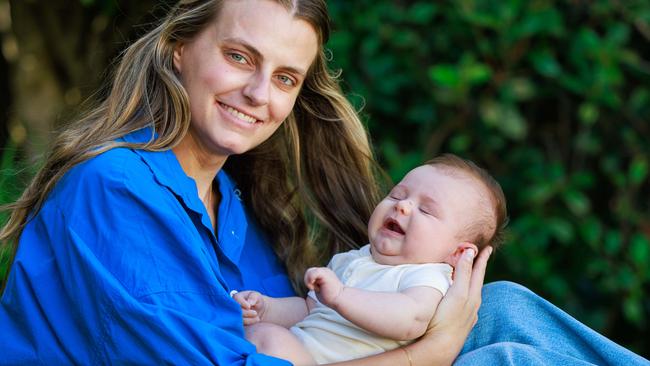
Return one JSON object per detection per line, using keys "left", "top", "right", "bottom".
{"left": 233, "top": 291, "right": 309, "bottom": 328}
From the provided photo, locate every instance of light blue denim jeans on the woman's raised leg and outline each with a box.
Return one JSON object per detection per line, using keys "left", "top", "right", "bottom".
{"left": 454, "top": 281, "right": 650, "bottom": 366}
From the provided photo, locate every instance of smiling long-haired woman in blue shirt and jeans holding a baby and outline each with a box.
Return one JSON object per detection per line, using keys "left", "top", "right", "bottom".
{"left": 0, "top": 0, "right": 636, "bottom": 365}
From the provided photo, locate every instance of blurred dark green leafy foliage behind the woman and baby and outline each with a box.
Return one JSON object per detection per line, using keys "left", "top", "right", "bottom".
{"left": 0, "top": 0, "right": 650, "bottom": 357}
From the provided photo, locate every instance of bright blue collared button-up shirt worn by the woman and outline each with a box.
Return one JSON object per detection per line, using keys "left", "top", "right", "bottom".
{"left": 0, "top": 129, "right": 293, "bottom": 365}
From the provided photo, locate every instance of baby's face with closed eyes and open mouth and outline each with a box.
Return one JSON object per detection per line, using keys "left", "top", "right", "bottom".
{"left": 368, "top": 165, "right": 482, "bottom": 265}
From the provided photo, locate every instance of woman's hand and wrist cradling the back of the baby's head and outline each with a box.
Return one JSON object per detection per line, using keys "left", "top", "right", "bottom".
{"left": 404, "top": 247, "right": 492, "bottom": 365}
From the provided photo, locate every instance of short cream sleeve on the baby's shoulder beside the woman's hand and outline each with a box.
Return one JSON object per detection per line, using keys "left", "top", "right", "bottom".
{"left": 398, "top": 263, "right": 453, "bottom": 295}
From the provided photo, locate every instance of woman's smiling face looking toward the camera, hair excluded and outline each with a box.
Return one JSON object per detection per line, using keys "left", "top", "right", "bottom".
{"left": 174, "top": 0, "right": 318, "bottom": 158}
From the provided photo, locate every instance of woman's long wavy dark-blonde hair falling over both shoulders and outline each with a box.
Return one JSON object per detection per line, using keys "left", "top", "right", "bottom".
{"left": 0, "top": 0, "right": 378, "bottom": 290}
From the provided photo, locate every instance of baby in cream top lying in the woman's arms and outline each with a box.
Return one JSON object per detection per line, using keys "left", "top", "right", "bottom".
{"left": 233, "top": 154, "right": 507, "bottom": 365}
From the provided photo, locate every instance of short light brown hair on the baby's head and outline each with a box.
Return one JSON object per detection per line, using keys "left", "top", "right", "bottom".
{"left": 425, "top": 154, "right": 508, "bottom": 250}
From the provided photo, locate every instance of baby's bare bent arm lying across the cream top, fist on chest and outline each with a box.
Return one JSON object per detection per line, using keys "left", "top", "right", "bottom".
{"left": 305, "top": 268, "right": 442, "bottom": 340}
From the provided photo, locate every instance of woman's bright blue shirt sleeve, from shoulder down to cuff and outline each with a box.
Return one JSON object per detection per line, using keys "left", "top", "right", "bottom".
{"left": 0, "top": 150, "right": 289, "bottom": 365}
